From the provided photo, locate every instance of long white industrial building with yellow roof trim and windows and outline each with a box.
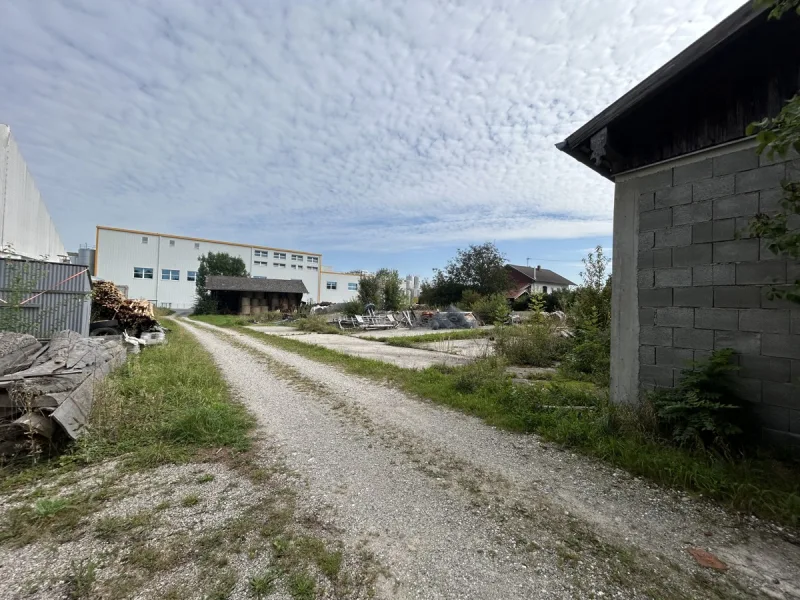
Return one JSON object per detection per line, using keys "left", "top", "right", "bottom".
{"left": 94, "top": 226, "right": 324, "bottom": 309}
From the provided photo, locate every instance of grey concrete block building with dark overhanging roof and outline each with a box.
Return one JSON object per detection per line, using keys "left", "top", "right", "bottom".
{"left": 559, "top": 2, "right": 800, "bottom": 444}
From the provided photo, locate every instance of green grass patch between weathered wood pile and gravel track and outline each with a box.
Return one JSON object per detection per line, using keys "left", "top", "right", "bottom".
{"left": 75, "top": 318, "right": 254, "bottom": 466}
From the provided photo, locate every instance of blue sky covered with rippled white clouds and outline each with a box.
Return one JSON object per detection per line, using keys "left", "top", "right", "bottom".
{"left": 0, "top": 0, "right": 741, "bottom": 277}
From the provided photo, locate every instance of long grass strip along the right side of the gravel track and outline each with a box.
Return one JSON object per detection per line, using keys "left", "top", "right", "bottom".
{"left": 239, "top": 328, "right": 800, "bottom": 526}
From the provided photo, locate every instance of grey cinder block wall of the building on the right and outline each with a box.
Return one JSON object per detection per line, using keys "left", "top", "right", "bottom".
{"left": 637, "top": 147, "right": 800, "bottom": 444}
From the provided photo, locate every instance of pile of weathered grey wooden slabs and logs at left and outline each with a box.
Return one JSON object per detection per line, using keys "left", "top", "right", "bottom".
{"left": 0, "top": 331, "right": 126, "bottom": 456}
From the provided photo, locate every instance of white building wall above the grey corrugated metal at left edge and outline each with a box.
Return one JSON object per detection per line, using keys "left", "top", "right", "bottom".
{"left": 0, "top": 124, "right": 67, "bottom": 261}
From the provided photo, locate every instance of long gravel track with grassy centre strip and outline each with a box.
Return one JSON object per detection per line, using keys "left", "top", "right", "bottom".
{"left": 184, "top": 321, "right": 800, "bottom": 599}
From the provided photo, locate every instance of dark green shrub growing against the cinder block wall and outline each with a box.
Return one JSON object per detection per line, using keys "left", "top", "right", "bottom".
{"left": 650, "top": 349, "right": 752, "bottom": 453}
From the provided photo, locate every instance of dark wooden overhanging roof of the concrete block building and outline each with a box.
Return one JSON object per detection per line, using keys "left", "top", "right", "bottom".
{"left": 557, "top": 0, "right": 800, "bottom": 178}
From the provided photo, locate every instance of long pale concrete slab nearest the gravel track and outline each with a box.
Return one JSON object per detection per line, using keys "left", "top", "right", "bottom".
{"left": 251, "top": 327, "right": 472, "bottom": 369}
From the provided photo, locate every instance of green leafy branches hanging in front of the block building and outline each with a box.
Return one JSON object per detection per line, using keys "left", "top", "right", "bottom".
{"left": 747, "top": 0, "right": 800, "bottom": 302}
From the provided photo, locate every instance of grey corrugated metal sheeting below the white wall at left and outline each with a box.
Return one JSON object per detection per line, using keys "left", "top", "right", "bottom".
{"left": 0, "top": 259, "right": 92, "bottom": 338}
